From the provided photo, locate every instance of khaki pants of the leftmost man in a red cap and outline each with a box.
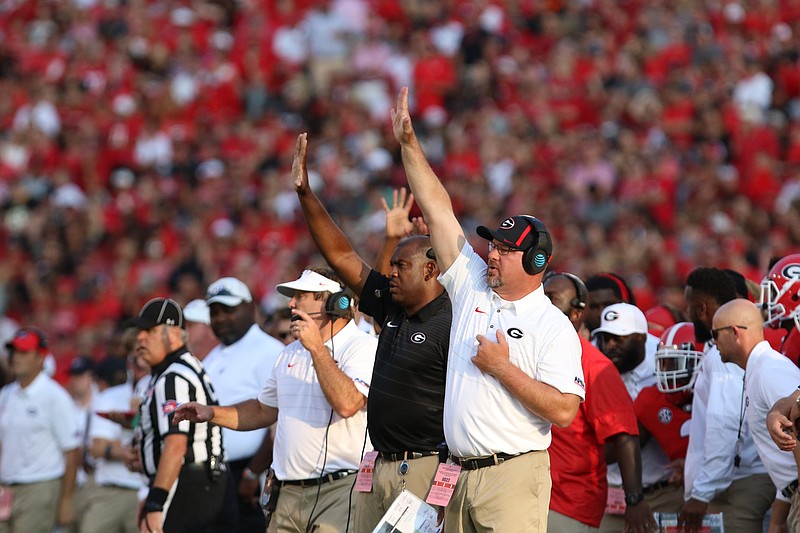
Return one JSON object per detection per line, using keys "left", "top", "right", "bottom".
{"left": 0, "top": 479, "right": 61, "bottom": 533}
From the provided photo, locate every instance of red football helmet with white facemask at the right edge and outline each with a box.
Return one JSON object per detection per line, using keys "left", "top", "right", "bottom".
{"left": 759, "top": 254, "right": 800, "bottom": 328}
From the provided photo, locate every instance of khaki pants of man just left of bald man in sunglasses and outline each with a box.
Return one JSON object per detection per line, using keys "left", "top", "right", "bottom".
{"left": 708, "top": 474, "right": 772, "bottom": 533}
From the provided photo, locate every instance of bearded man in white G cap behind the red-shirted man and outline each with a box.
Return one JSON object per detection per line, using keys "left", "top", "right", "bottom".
{"left": 592, "top": 303, "right": 682, "bottom": 532}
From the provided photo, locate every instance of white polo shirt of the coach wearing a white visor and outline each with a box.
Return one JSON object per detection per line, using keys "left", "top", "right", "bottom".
{"left": 258, "top": 320, "right": 378, "bottom": 481}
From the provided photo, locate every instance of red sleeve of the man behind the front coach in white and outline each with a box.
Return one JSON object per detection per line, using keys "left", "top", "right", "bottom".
{"left": 581, "top": 339, "right": 639, "bottom": 442}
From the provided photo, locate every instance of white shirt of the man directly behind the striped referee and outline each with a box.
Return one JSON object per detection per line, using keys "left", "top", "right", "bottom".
{"left": 203, "top": 324, "right": 284, "bottom": 461}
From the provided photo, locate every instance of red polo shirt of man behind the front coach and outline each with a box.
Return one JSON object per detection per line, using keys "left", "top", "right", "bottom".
{"left": 549, "top": 339, "right": 639, "bottom": 528}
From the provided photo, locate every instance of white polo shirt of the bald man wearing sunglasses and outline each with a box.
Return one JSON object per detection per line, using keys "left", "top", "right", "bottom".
{"left": 744, "top": 341, "right": 800, "bottom": 501}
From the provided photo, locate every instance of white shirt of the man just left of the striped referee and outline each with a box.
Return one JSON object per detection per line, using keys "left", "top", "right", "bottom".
{"left": 89, "top": 383, "right": 144, "bottom": 489}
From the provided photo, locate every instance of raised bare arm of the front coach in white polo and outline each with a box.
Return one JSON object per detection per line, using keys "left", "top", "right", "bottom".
{"left": 391, "top": 87, "right": 466, "bottom": 272}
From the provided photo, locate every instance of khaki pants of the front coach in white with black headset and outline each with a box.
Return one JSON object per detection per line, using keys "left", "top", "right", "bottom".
{"left": 444, "top": 450, "right": 552, "bottom": 533}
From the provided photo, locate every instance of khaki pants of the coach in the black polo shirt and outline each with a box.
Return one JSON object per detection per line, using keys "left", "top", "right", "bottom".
{"left": 353, "top": 455, "right": 439, "bottom": 533}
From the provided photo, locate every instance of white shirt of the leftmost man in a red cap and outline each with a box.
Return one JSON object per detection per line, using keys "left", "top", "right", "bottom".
{"left": 0, "top": 372, "right": 81, "bottom": 483}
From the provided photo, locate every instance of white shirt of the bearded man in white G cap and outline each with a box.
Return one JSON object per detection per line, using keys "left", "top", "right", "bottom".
{"left": 608, "top": 333, "right": 671, "bottom": 486}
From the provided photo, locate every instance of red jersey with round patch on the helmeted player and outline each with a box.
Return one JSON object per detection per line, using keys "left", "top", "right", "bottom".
{"left": 633, "top": 385, "right": 692, "bottom": 461}
